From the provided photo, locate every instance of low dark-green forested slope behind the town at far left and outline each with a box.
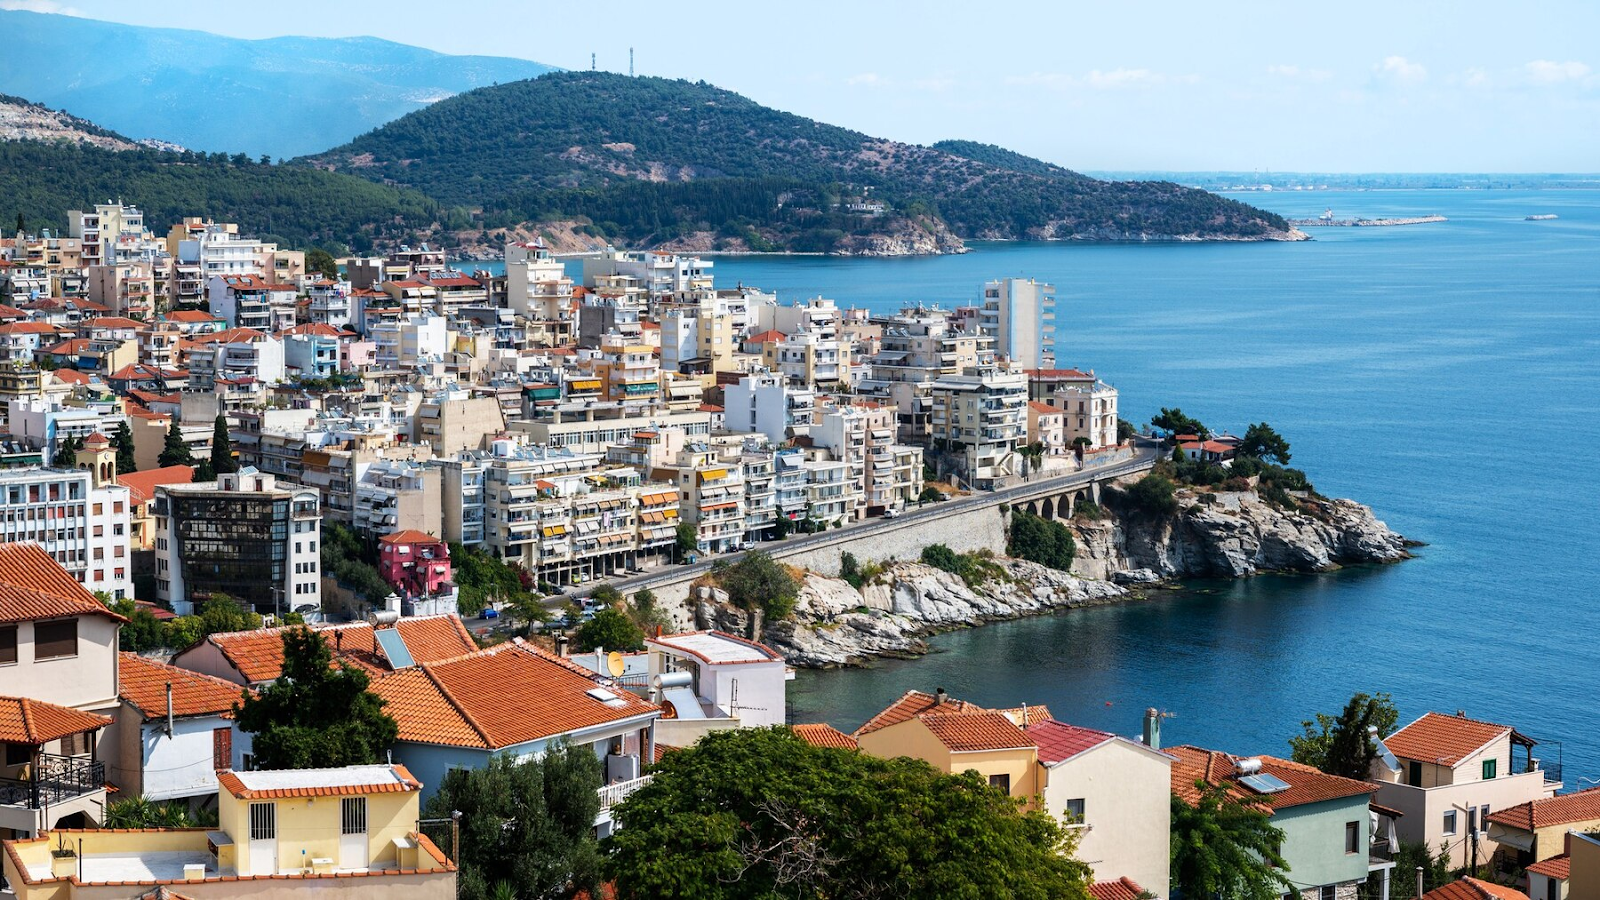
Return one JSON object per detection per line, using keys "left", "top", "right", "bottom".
{"left": 0, "top": 141, "right": 438, "bottom": 250}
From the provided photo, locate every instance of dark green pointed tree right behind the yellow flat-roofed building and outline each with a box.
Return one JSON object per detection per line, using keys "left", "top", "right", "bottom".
{"left": 234, "top": 628, "right": 400, "bottom": 769}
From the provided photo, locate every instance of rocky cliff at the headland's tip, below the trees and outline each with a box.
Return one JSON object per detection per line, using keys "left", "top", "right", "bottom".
{"left": 1072, "top": 492, "right": 1410, "bottom": 583}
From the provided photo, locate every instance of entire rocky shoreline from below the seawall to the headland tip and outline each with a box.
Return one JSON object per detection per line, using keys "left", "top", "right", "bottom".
{"left": 686, "top": 492, "right": 1414, "bottom": 668}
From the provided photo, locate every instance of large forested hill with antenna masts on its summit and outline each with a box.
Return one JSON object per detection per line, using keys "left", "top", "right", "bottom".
{"left": 304, "top": 72, "right": 1288, "bottom": 248}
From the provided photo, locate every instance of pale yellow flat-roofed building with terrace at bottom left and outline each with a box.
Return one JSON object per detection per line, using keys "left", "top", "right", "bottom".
{"left": 3, "top": 765, "right": 456, "bottom": 900}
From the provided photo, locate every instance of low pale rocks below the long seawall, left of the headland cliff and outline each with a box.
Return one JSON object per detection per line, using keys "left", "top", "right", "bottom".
{"left": 691, "top": 559, "right": 1128, "bottom": 668}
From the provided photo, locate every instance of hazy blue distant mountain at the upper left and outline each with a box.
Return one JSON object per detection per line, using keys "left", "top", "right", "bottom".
{"left": 0, "top": 5, "right": 552, "bottom": 159}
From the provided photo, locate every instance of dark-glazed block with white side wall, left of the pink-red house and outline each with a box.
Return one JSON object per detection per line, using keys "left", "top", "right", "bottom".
{"left": 155, "top": 466, "right": 322, "bottom": 615}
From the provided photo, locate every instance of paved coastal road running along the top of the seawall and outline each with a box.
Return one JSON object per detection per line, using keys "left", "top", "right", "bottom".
{"left": 582, "top": 447, "right": 1160, "bottom": 607}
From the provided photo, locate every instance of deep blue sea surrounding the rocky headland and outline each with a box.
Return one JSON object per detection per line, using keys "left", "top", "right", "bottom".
{"left": 715, "top": 191, "right": 1600, "bottom": 778}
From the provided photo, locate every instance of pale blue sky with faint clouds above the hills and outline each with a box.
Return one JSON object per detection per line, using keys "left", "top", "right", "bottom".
{"left": 0, "top": 0, "right": 1600, "bottom": 173}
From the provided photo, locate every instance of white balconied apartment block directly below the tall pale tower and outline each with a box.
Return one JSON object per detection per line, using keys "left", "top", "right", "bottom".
{"left": 931, "top": 368, "right": 1027, "bottom": 490}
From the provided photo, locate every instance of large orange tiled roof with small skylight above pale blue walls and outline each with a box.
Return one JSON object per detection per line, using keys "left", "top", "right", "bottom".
{"left": 373, "top": 641, "right": 659, "bottom": 749}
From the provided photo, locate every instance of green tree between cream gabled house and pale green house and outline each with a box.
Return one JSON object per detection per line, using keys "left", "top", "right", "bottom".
{"left": 1171, "top": 781, "right": 1294, "bottom": 900}
